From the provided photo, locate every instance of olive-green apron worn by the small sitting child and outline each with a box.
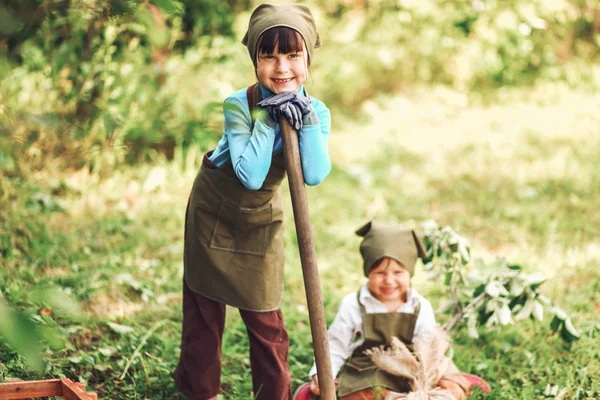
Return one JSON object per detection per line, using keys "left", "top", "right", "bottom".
{"left": 338, "top": 290, "right": 421, "bottom": 396}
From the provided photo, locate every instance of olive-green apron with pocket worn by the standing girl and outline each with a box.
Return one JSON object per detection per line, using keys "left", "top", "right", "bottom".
{"left": 184, "top": 85, "right": 285, "bottom": 311}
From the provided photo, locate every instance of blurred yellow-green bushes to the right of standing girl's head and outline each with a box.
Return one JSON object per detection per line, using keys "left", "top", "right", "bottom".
{"left": 312, "top": 0, "right": 600, "bottom": 107}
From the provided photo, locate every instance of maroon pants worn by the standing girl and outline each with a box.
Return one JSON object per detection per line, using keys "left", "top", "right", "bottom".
{"left": 175, "top": 281, "right": 292, "bottom": 400}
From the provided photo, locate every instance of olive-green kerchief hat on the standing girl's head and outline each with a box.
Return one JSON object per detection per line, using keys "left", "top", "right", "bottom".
{"left": 242, "top": 3, "right": 321, "bottom": 66}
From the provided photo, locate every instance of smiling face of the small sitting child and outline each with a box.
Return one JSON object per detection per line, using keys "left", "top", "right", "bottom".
{"left": 367, "top": 257, "right": 410, "bottom": 304}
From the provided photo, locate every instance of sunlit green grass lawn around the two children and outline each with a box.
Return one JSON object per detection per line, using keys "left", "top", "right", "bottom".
{"left": 0, "top": 83, "right": 600, "bottom": 400}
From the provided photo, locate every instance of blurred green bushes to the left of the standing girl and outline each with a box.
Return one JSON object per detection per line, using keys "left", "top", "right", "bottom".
{"left": 0, "top": 0, "right": 246, "bottom": 171}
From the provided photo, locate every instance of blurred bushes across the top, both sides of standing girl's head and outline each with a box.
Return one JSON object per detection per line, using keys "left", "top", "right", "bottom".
{"left": 0, "top": 0, "right": 600, "bottom": 174}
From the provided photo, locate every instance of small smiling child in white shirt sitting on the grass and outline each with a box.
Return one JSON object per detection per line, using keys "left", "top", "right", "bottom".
{"left": 294, "top": 221, "right": 470, "bottom": 400}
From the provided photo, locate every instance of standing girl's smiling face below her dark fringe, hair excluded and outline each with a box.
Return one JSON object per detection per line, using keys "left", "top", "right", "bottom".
{"left": 256, "top": 42, "right": 308, "bottom": 94}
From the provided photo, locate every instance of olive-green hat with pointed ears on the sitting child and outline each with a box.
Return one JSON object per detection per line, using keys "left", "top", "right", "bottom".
{"left": 356, "top": 221, "right": 425, "bottom": 276}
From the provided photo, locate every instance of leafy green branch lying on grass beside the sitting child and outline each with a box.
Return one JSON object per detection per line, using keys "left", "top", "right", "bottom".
{"left": 421, "top": 221, "right": 580, "bottom": 342}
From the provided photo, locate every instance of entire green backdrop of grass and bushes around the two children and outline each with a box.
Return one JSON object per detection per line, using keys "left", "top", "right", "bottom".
{"left": 0, "top": 0, "right": 600, "bottom": 400}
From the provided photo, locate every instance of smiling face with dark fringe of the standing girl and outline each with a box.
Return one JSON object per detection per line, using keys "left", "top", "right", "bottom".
{"left": 256, "top": 27, "right": 308, "bottom": 94}
